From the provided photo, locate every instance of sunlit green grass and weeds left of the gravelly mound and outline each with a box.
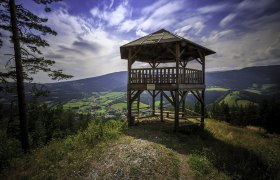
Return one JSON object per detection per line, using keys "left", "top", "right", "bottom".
{"left": 0, "top": 121, "right": 125, "bottom": 179}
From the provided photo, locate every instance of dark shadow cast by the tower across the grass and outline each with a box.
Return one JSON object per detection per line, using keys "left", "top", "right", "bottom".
{"left": 126, "top": 120, "right": 278, "bottom": 179}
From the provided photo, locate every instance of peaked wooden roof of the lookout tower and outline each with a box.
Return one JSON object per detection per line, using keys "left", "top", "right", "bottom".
{"left": 120, "top": 29, "right": 215, "bottom": 63}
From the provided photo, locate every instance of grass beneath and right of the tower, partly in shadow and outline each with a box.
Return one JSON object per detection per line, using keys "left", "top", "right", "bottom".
{"left": 128, "top": 117, "right": 280, "bottom": 179}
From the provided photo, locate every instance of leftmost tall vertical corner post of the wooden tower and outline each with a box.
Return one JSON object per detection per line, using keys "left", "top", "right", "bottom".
{"left": 127, "top": 49, "right": 134, "bottom": 126}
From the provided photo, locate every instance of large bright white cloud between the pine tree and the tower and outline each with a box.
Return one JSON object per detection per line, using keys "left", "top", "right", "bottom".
{"left": 36, "top": 10, "right": 126, "bottom": 82}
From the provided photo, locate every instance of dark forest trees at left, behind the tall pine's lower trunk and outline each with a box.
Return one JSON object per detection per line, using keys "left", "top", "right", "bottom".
{"left": 4, "top": 101, "right": 91, "bottom": 148}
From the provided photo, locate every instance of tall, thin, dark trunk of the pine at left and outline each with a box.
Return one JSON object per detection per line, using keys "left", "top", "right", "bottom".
{"left": 9, "top": 0, "right": 30, "bottom": 152}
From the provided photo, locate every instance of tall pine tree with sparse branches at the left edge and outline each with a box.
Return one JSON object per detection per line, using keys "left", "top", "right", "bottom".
{"left": 0, "top": 0, "right": 72, "bottom": 152}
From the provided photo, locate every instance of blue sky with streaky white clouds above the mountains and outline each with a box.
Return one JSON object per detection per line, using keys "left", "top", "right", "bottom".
{"left": 0, "top": 0, "right": 280, "bottom": 82}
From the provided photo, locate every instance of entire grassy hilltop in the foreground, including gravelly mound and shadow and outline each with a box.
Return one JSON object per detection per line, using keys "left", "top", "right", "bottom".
{"left": 0, "top": 119, "right": 280, "bottom": 179}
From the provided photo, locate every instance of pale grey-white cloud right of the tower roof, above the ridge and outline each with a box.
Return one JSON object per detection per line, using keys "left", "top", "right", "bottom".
{"left": 204, "top": 23, "right": 280, "bottom": 71}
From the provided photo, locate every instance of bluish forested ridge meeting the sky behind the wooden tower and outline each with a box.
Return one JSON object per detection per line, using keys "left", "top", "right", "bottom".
{"left": 46, "top": 65, "right": 280, "bottom": 92}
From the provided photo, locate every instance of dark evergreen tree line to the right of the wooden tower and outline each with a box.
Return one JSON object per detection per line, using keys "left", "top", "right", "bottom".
{"left": 208, "top": 100, "right": 280, "bottom": 133}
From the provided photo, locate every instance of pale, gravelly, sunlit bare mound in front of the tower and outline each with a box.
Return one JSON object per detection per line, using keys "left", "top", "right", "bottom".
{"left": 86, "top": 136, "right": 192, "bottom": 179}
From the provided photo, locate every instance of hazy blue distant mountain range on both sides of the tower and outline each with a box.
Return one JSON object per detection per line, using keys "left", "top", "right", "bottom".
{"left": 1, "top": 65, "right": 280, "bottom": 102}
